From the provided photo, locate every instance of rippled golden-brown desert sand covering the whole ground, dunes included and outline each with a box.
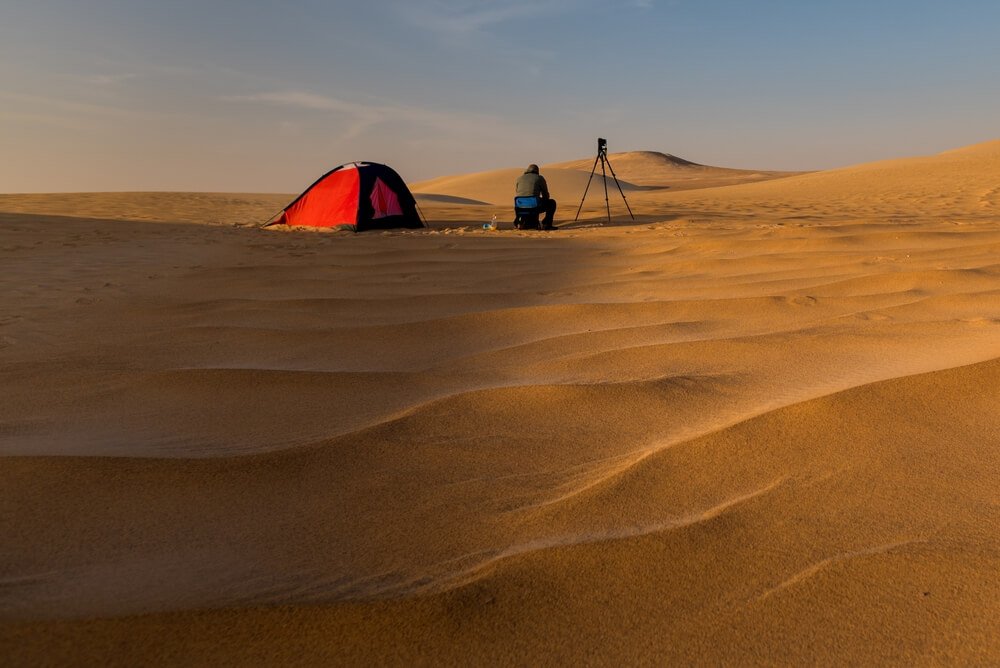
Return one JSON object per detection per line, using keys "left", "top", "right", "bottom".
{"left": 0, "top": 141, "right": 1000, "bottom": 666}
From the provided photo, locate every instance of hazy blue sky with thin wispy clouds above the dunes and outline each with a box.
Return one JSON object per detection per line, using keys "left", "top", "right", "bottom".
{"left": 0, "top": 0, "right": 1000, "bottom": 193}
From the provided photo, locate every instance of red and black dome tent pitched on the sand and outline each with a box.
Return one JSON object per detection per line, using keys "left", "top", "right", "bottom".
{"left": 271, "top": 162, "right": 424, "bottom": 232}
